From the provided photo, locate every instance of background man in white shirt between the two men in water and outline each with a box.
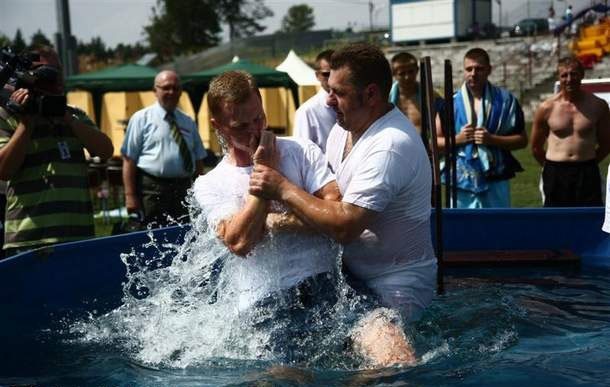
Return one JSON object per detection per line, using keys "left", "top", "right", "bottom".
{"left": 293, "top": 50, "right": 337, "bottom": 152}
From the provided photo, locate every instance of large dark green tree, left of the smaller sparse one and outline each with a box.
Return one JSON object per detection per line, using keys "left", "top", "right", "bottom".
{"left": 144, "top": 0, "right": 221, "bottom": 61}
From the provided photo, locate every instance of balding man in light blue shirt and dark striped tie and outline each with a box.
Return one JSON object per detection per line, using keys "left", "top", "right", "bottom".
{"left": 121, "top": 71, "right": 206, "bottom": 225}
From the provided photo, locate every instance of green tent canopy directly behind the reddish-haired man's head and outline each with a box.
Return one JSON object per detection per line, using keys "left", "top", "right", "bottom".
{"left": 182, "top": 57, "right": 299, "bottom": 112}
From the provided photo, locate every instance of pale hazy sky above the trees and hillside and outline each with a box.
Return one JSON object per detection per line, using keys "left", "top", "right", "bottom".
{"left": 0, "top": 0, "right": 590, "bottom": 47}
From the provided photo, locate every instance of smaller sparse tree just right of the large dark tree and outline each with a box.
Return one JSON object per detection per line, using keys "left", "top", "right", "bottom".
{"left": 218, "top": 0, "right": 273, "bottom": 40}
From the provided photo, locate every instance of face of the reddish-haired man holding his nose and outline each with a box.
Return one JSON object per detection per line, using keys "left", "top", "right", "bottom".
{"left": 212, "top": 92, "right": 267, "bottom": 154}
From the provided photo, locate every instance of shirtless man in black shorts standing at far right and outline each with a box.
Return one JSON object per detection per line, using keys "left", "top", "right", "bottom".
{"left": 532, "top": 58, "right": 610, "bottom": 207}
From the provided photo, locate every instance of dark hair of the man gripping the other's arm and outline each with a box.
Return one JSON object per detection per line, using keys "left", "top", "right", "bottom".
{"left": 330, "top": 43, "right": 392, "bottom": 100}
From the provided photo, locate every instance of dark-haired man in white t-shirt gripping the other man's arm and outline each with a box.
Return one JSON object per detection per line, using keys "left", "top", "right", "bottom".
{"left": 250, "top": 43, "right": 436, "bottom": 366}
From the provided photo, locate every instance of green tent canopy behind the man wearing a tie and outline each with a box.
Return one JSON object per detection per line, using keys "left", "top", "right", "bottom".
{"left": 66, "top": 64, "right": 159, "bottom": 124}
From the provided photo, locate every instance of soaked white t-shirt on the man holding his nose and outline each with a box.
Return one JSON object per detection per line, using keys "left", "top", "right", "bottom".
{"left": 193, "top": 138, "right": 338, "bottom": 309}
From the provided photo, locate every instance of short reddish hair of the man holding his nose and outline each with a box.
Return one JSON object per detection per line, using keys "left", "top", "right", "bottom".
{"left": 208, "top": 70, "right": 260, "bottom": 117}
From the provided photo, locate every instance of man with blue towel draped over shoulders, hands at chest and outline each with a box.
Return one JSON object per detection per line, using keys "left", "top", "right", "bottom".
{"left": 437, "top": 48, "right": 527, "bottom": 208}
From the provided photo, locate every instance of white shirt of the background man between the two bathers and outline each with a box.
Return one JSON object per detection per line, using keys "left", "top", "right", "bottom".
{"left": 293, "top": 89, "right": 337, "bottom": 152}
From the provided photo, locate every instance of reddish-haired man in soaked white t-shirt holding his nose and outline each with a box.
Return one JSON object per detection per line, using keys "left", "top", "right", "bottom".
{"left": 193, "top": 71, "right": 339, "bottom": 316}
